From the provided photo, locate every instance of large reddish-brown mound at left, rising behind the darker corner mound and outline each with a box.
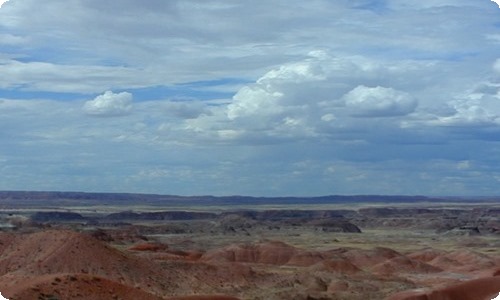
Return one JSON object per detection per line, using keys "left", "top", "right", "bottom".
{"left": 0, "top": 230, "right": 204, "bottom": 294}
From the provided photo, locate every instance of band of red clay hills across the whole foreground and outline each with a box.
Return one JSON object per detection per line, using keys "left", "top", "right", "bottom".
{"left": 0, "top": 230, "right": 500, "bottom": 300}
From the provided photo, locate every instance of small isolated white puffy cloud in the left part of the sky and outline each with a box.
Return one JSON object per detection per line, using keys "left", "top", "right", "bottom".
{"left": 83, "top": 91, "right": 132, "bottom": 116}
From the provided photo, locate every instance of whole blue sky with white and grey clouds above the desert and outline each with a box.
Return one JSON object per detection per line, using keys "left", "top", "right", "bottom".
{"left": 0, "top": 0, "right": 500, "bottom": 196}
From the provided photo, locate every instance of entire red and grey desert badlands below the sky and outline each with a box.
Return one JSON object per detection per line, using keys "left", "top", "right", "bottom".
{"left": 0, "top": 192, "right": 500, "bottom": 300}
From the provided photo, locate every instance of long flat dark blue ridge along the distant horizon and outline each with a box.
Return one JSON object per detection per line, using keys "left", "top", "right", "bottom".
{"left": 0, "top": 191, "right": 499, "bottom": 206}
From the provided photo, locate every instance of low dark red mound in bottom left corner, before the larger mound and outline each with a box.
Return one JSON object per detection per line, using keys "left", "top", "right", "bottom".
{"left": 2, "top": 274, "right": 164, "bottom": 300}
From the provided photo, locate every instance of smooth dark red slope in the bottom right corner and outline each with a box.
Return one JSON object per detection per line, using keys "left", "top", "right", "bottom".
{"left": 388, "top": 277, "right": 500, "bottom": 300}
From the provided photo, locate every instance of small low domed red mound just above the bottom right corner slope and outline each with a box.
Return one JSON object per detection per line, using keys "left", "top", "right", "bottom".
{"left": 371, "top": 256, "right": 443, "bottom": 275}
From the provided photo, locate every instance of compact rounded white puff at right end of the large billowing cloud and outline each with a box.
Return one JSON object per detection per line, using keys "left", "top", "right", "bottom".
{"left": 343, "top": 85, "right": 417, "bottom": 117}
